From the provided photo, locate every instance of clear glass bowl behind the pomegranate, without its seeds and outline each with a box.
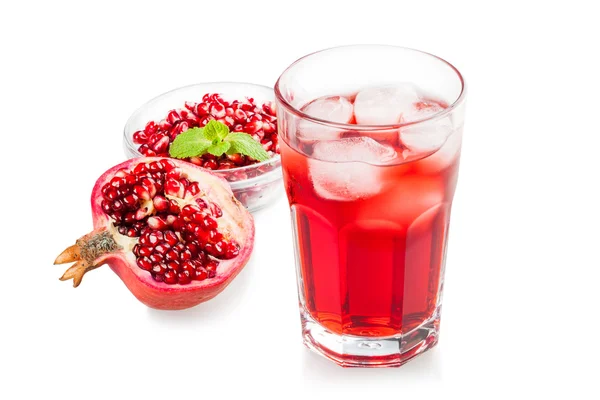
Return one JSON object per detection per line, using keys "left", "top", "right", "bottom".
{"left": 123, "top": 82, "right": 283, "bottom": 211}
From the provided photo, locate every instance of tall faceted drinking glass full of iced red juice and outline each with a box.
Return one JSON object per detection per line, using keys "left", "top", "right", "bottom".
{"left": 275, "top": 45, "right": 465, "bottom": 366}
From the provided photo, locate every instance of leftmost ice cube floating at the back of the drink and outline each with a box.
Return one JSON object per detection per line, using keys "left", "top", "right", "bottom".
{"left": 297, "top": 96, "right": 354, "bottom": 142}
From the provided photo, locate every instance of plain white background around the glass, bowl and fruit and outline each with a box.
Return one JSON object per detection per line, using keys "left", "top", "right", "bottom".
{"left": 0, "top": 0, "right": 600, "bottom": 400}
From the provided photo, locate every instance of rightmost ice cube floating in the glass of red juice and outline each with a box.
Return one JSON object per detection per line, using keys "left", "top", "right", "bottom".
{"left": 400, "top": 101, "right": 452, "bottom": 153}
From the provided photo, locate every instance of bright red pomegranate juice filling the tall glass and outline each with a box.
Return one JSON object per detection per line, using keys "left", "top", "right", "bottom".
{"left": 280, "top": 96, "right": 461, "bottom": 337}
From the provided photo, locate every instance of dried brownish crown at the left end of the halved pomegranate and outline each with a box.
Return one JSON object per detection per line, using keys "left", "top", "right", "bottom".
{"left": 54, "top": 229, "right": 122, "bottom": 287}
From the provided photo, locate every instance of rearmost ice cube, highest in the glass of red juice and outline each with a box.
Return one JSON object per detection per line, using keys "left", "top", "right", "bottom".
{"left": 354, "top": 83, "right": 421, "bottom": 125}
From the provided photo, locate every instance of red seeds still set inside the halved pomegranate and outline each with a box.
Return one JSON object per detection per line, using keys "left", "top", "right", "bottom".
{"left": 101, "top": 160, "right": 240, "bottom": 284}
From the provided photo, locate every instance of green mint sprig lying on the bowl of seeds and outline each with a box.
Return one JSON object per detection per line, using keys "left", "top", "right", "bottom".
{"left": 169, "top": 120, "right": 269, "bottom": 161}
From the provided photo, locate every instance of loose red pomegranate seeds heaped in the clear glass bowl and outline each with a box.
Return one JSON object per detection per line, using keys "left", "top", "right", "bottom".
{"left": 133, "top": 93, "right": 279, "bottom": 170}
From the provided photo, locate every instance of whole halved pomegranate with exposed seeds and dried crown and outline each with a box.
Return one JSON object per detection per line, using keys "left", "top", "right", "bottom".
{"left": 55, "top": 157, "right": 254, "bottom": 310}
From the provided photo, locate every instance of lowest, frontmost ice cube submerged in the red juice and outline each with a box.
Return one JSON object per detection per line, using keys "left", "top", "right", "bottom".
{"left": 308, "top": 137, "right": 396, "bottom": 201}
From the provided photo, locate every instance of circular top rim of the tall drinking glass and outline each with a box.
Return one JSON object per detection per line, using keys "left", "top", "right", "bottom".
{"left": 274, "top": 44, "right": 467, "bottom": 131}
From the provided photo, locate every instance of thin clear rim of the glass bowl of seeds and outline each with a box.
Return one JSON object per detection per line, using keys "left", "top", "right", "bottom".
{"left": 123, "top": 81, "right": 281, "bottom": 173}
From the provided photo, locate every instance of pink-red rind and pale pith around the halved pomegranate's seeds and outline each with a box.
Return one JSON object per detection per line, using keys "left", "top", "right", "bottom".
{"left": 91, "top": 157, "right": 255, "bottom": 310}
